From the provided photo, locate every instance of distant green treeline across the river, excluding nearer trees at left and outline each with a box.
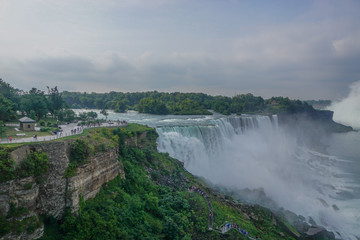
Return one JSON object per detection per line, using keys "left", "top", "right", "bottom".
{"left": 62, "top": 91, "right": 315, "bottom": 115}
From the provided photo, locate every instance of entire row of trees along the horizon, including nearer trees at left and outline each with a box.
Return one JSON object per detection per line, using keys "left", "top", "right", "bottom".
{"left": 0, "top": 79, "right": 315, "bottom": 122}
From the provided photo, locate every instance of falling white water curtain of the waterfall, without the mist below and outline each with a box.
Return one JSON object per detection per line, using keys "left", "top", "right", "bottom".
{"left": 156, "top": 115, "right": 278, "bottom": 178}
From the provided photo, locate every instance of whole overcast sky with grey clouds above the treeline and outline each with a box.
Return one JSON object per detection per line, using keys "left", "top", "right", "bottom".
{"left": 0, "top": 0, "right": 360, "bottom": 100}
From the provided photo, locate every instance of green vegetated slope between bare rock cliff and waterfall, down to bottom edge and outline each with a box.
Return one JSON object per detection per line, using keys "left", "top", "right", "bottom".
{"left": 42, "top": 124, "right": 298, "bottom": 239}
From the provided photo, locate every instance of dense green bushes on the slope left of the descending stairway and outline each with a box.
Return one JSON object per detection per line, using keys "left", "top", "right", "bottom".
{"left": 42, "top": 148, "right": 200, "bottom": 239}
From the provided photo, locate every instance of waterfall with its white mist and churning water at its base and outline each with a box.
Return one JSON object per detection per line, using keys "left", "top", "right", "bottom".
{"left": 156, "top": 115, "right": 359, "bottom": 239}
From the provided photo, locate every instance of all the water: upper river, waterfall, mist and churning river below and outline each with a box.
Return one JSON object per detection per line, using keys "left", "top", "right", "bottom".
{"left": 76, "top": 110, "right": 360, "bottom": 239}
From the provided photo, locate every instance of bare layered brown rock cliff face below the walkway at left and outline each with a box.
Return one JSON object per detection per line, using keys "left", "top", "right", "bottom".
{"left": 0, "top": 140, "right": 124, "bottom": 240}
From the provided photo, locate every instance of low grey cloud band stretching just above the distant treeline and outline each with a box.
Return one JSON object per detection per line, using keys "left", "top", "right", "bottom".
{"left": 0, "top": 48, "right": 356, "bottom": 99}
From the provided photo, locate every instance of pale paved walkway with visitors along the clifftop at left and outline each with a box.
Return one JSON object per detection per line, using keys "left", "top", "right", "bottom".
{"left": 0, "top": 122, "right": 127, "bottom": 144}
